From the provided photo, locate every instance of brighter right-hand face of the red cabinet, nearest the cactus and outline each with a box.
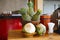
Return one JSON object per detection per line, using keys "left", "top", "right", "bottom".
{"left": 6, "top": 18, "right": 22, "bottom": 30}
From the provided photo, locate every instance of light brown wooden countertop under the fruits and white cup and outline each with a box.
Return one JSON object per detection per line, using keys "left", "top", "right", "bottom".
{"left": 8, "top": 31, "right": 60, "bottom": 40}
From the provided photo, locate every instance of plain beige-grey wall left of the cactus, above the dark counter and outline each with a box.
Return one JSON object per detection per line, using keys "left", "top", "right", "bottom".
{"left": 0, "top": 0, "right": 28, "bottom": 12}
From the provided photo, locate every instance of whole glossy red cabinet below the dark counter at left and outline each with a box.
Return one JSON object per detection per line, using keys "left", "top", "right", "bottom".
{"left": 0, "top": 17, "right": 22, "bottom": 40}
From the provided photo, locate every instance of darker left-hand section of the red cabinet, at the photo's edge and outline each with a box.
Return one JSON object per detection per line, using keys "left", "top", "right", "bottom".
{"left": 0, "top": 19, "right": 8, "bottom": 40}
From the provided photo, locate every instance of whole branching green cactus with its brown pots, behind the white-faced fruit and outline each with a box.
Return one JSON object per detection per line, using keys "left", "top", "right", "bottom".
{"left": 19, "top": 1, "right": 41, "bottom": 25}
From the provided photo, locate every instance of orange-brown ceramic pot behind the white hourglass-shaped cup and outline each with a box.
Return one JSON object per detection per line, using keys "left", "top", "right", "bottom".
{"left": 40, "top": 15, "right": 51, "bottom": 31}
